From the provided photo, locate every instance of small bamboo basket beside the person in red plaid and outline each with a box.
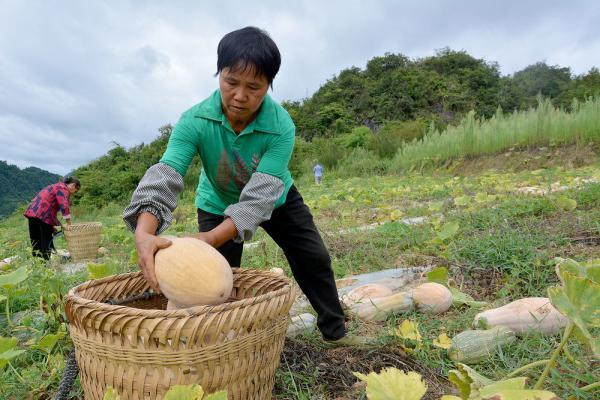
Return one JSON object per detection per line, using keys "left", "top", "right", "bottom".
{"left": 62, "top": 222, "right": 102, "bottom": 261}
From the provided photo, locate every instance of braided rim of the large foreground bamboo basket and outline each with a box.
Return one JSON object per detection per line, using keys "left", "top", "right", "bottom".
{"left": 64, "top": 268, "right": 297, "bottom": 318}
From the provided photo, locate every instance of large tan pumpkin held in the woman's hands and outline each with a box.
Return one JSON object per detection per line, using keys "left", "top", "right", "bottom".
{"left": 154, "top": 238, "right": 233, "bottom": 308}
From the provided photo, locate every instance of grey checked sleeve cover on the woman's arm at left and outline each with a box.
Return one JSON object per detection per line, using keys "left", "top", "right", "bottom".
{"left": 123, "top": 163, "right": 183, "bottom": 234}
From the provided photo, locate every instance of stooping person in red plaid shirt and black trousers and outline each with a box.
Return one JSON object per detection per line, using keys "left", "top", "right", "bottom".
{"left": 23, "top": 177, "right": 81, "bottom": 260}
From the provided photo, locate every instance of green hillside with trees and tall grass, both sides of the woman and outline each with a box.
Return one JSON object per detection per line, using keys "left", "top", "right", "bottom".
{"left": 48, "top": 49, "right": 600, "bottom": 207}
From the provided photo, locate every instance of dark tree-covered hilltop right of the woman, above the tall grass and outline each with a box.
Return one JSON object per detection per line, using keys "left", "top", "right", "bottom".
{"left": 284, "top": 49, "right": 600, "bottom": 140}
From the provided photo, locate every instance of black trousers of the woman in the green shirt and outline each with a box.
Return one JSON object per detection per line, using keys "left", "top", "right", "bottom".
{"left": 198, "top": 186, "right": 346, "bottom": 340}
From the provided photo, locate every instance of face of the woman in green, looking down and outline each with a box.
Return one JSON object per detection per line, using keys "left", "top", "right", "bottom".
{"left": 219, "top": 66, "right": 269, "bottom": 129}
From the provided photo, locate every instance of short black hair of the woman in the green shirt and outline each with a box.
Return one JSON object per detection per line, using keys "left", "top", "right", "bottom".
{"left": 216, "top": 26, "right": 281, "bottom": 86}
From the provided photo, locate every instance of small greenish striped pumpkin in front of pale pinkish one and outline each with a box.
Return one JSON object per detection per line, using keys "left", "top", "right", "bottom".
{"left": 448, "top": 326, "right": 516, "bottom": 363}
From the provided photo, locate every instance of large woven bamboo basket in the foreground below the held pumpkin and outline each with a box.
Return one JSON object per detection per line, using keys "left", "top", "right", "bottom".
{"left": 65, "top": 269, "right": 298, "bottom": 400}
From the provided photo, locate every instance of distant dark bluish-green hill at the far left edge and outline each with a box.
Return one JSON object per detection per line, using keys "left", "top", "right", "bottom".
{"left": 0, "top": 161, "right": 60, "bottom": 218}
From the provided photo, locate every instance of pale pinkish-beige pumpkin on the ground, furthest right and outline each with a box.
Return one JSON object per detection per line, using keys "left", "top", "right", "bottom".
{"left": 473, "top": 297, "right": 569, "bottom": 335}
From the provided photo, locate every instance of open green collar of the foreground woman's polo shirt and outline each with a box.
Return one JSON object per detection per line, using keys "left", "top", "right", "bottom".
{"left": 195, "top": 89, "right": 281, "bottom": 135}
